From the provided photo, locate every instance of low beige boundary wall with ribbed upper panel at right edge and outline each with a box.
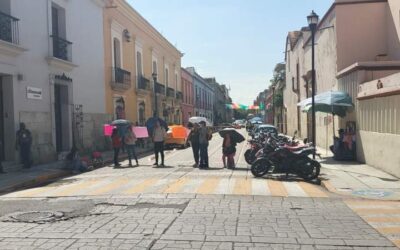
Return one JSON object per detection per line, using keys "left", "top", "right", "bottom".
{"left": 357, "top": 73, "right": 400, "bottom": 177}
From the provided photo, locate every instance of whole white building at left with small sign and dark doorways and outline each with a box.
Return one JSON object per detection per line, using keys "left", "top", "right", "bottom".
{"left": 0, "top": 0, "right": 110, "bottom": 170}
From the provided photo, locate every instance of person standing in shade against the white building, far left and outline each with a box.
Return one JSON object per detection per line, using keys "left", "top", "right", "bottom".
{"left": 15, "top": 122, "right": 32, "bottom": 168}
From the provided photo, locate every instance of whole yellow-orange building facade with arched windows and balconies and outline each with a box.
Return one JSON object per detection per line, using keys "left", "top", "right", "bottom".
{"left": 103, "top": 0, "right": 182, "bottom": 125}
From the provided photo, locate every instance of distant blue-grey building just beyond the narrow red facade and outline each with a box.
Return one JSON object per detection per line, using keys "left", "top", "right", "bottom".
{"left": 186, "top": 67, "right": 214, "bottom": 123}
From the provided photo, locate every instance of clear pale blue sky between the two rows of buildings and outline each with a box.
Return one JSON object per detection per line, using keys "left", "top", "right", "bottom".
{"left": 128, "top": 0, "right": 333, "bottom": 105}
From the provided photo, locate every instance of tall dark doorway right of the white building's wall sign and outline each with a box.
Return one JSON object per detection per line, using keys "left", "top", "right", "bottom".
{"left": 54, "top": 84, "right": 70, "bottom": 153}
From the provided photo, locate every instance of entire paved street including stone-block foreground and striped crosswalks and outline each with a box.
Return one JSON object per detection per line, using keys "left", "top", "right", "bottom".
{"left": 0, "top": 129, "right": 400, "bottom": 249}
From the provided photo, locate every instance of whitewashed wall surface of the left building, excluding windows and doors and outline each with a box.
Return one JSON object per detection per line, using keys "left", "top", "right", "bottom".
{"left": 0, "top": 0, "right": 105, "bottom": 166}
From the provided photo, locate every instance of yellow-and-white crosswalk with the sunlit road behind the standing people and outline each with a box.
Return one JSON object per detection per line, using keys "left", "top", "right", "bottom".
{"left": 2, "top": 130, "right": 330, "bottom": 197}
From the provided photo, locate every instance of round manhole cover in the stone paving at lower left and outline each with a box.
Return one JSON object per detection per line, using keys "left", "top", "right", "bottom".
{"left": 8, "top": 211, "right": 64, "bottom": 223}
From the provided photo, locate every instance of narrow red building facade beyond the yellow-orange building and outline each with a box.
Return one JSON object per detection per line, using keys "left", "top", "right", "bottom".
{"left": 181, "top": 68, "right": 194, "bottom": 125}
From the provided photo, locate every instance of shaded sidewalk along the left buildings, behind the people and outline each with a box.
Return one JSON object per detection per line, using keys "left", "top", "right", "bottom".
{"left": 0, "top": 147, "right": 153, "bottom": 194}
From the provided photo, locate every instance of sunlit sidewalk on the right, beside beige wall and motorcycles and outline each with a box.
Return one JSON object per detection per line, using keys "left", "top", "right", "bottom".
{"left": 318, "top": 148, "right": 400, "bottom": 200}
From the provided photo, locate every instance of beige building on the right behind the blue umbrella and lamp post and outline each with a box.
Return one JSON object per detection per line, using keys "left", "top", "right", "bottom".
{"left": 284, "top": 0, "right": 400, "bottom": 176}
